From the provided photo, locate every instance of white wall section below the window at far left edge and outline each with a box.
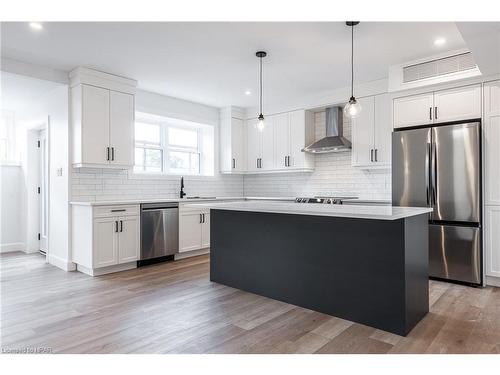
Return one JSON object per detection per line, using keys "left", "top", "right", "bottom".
{"left": 0, "top": 165, "right": 26, "bottom": 253}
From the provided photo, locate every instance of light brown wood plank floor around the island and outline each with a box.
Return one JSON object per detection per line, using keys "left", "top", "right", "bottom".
{"left": 0, "top": 253, "right": 500, "bottom": 353}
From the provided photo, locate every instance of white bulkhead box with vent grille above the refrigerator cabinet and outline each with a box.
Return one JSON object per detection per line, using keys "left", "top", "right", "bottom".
{"left": 389, "top": 50, "right": 481, "bottom": 91}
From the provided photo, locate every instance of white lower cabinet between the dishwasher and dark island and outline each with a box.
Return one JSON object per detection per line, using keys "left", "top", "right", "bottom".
{"left": 179, "top": 205, "right": 210, "bottom": 253}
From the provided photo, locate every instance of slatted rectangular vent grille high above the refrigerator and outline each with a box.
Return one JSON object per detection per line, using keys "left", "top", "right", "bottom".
{"left": 403, "top": 52, "right": 477, "bottom": 83}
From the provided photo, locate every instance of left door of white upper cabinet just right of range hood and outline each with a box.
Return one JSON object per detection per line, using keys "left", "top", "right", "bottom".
{"left": 352, "top": 96, "right": 375, "bottom": 167}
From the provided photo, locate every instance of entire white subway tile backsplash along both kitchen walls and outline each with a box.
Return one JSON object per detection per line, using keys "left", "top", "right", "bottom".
{"left": 71, "top": 112, "right": 391, "bottom": 201}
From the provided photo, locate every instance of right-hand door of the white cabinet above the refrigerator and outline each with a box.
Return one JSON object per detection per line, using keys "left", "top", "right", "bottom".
{"left": 434, "top": 85, "right": 481, "bottom": 122}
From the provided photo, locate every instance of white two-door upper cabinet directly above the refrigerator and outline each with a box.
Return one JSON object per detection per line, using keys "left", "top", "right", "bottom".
{"left": 393, "top": 85, "right": 481, "bottom": 128}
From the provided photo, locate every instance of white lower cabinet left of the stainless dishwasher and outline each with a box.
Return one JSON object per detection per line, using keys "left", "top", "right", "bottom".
{"left": 71, "top": 205, "right": 141, "bottom": 276}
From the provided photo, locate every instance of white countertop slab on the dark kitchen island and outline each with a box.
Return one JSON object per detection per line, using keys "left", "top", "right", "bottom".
{"left": 185, "top": 201, "right": 432, "bottom": 220}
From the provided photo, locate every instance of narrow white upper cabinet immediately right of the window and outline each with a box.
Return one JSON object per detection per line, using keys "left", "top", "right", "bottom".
{"left": 220, "top": 107, "right": 247, "bottom": 173}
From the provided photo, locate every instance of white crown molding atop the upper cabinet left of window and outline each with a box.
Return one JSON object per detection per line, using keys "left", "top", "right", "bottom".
{"left": 69, "top": 66, "right": 137, "bottom": 94}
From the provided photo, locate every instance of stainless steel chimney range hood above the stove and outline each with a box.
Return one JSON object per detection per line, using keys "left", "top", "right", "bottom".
{"left": 302, "top": 107, "right": 351, "bottom": 154}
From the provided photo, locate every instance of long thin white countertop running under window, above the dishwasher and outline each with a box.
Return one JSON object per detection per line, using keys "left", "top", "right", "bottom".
{"left": 69, "top": 197, "right": 295, "bottom": 206}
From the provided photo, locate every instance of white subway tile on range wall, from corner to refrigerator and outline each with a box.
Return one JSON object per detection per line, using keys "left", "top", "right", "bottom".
{"left": 244, "top": 111, "right": 391, "bottom": 200}
